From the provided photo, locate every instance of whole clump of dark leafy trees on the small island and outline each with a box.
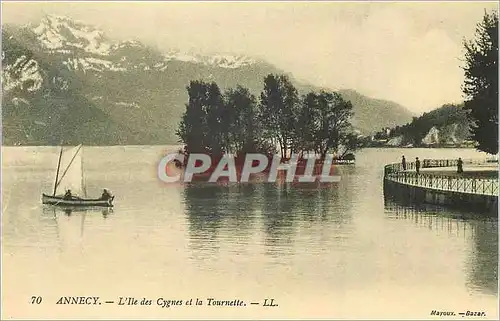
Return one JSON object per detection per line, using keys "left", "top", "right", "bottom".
{"left": 177, "top": 74, "right": 359, "bottom": 158}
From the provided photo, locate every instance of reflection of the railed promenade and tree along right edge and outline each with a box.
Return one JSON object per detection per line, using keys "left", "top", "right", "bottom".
{"left": 385, "top": 200, "right": 498, "bottom": 295}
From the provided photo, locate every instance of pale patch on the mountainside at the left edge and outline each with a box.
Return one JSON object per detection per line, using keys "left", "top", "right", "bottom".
{"left": 2, "top": 55, "right": 43, "bottom": 93}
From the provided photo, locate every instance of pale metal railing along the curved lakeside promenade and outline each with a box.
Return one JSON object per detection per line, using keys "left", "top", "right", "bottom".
{"left": 384, "top": 159, "right": 498, "bottom": 196}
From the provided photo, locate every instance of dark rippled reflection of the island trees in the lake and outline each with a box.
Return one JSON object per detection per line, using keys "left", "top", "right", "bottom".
{"left": 183, "top": 181, "right": 352, "bottom": 256}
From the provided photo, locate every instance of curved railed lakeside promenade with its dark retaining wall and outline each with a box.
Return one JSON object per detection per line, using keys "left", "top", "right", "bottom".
{"left": 384, "top": 159, "right": 498, "bottom": 216}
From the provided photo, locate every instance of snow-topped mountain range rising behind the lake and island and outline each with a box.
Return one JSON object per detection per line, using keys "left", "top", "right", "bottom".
{"left": 2, "top": 15, "right": 413, "bottom": 145}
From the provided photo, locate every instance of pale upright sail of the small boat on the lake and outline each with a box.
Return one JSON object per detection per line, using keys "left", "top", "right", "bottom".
{"left": 56, "top": 145, "right": 85, "bottom": 196}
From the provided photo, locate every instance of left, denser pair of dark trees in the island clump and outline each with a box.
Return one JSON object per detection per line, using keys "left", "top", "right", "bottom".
{"left": 176, "top": 81, "right": 274, "bottom": 158}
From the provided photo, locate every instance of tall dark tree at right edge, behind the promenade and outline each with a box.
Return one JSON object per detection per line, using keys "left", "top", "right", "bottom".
{"left": 462, "top": 12, "right": 498, "bottom": 154}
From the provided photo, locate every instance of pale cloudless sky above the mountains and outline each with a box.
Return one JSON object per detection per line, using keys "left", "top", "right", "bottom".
{"left": 2, "top": 1, "right": 498, "bottom": 114}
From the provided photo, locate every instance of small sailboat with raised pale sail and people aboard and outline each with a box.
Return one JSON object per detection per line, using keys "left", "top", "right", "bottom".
{"left": 42, "top": 145, "right": 115, "bottom": 207}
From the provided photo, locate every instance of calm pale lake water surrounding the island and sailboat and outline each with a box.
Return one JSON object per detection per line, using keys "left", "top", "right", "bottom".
{"left": 2, "top": 146, "right": 498, "bottom": 319}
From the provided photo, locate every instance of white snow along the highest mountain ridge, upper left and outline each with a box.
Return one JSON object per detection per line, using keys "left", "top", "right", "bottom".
{"left": 28, "top": 15, "right": 255, "bottom": 72}
